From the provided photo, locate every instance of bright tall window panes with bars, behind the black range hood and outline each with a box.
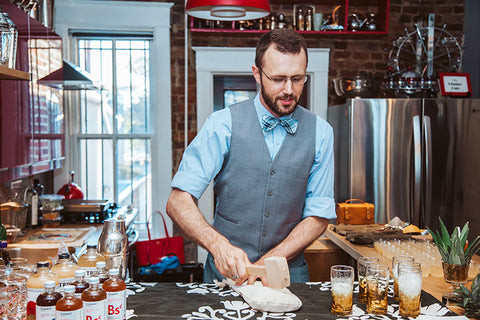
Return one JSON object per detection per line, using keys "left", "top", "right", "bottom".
{"left": 76, "top": 35, "right": 152, "bottom": 220}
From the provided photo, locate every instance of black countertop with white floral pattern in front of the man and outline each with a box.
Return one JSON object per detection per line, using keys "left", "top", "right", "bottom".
{"left": 127, "top": 282, "right": 458, "bottom": 320}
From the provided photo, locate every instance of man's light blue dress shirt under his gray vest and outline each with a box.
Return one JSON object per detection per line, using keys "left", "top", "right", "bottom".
{"left": 171, "top": 94, "right": 336, "bottom": 219}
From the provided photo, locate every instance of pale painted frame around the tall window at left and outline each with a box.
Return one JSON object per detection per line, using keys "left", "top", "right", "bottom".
{"left": 54, "top": 0, "right": 173, "bottom": 238}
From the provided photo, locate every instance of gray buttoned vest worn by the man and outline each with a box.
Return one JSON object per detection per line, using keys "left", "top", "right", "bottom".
{"left": 214, "top": 100, "right": 316, "bottom": 267}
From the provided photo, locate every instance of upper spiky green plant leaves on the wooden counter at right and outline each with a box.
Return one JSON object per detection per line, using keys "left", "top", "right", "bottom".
{"left": 428, "top": 217, "right": 480, "bottom": 266}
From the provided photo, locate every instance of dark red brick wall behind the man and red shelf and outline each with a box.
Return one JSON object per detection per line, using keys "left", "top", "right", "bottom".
{"left": 144, "top": 0, "right": 464, "bottom": 261}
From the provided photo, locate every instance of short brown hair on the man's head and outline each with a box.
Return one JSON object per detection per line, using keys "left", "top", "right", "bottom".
{"left": 255, "top": 29, "right": 308, "bottom": 68}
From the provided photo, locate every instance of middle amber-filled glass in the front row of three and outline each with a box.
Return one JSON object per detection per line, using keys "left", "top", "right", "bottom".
{"left": 367, "top": 265, "right": 390, "bottom": 314}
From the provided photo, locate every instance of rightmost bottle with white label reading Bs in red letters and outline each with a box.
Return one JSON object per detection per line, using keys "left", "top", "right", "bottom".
{"left": 102, "top": 269, "right": 127, "bottom": 320}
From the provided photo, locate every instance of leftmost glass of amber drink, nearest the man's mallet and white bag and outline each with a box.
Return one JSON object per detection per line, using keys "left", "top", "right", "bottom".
{"left": 330, "top": 265, "right": 355, "bottom": 316}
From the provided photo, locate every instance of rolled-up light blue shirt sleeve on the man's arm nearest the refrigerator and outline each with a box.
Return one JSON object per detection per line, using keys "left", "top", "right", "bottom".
{"left": 303, "top": 117, "right": 336, "bottom": 219}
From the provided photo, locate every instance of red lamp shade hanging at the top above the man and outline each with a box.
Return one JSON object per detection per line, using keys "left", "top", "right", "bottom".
{"left": 185, "top": 0, "right": 270, "bottom": 21}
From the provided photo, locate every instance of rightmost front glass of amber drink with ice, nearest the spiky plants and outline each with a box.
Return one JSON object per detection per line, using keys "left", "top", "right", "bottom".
{"left": 398, "top": 264, "right": 422, "bottom": 317}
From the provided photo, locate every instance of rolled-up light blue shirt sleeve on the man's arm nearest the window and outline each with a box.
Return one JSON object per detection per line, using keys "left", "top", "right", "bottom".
{"left": 170, "top": 108, "right": 231, "bottom": 199}
